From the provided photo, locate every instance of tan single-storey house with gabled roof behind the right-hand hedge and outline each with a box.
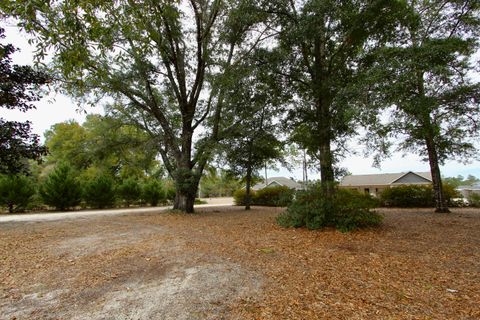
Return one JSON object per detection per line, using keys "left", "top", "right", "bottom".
{"left": 340, "top": 171, "right": 432, "bottom": 196}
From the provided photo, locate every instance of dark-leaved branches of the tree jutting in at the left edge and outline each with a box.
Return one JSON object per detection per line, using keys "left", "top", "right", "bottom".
{"left": 0, "top": 27, "right": 49, "bottom": 173}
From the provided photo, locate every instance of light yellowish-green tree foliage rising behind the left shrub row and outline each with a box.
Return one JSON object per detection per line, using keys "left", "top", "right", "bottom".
{"left": 45, "top": 114, "right": 158, "bottom": 177}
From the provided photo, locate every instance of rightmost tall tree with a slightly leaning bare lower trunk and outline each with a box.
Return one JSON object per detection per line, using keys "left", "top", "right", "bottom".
{"left": 369, "top": 0, "right": 480, "bottom": 212}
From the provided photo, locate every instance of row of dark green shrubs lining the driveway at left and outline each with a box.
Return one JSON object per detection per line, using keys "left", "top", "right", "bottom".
{"left": 0, "top": 164, "right": 175, "bottom": 212}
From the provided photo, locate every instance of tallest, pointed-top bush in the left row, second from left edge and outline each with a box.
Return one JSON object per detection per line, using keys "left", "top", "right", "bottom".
{"left": 40, "top": 163, "right": 82, "bottom": 210}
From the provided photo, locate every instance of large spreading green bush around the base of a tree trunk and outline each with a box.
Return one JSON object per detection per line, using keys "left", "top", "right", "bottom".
{"left": 277, "top": 186, "right": 383, "bottom": 232}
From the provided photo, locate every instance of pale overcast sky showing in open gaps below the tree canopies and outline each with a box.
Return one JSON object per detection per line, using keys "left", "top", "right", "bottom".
{"left": 0, "top": 24, "right": 480, "bottom": 180}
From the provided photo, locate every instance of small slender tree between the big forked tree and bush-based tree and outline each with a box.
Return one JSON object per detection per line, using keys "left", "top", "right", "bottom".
{"left": 221, "top": 53, "right": 285, "bottom": 210}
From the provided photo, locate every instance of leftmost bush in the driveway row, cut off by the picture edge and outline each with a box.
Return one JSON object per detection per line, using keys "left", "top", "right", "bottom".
{"left": 0, "top": 175, "right": 35, "bottom": 213}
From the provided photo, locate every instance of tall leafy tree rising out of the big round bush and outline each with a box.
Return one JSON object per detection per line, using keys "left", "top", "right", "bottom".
{"left": 268, "top": 0, "right": 402, "bottom": 196}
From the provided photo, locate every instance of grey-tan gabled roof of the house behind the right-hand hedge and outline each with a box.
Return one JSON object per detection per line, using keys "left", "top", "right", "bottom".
{"left": 340, "top": 171, "right": 432, "bottom": 187}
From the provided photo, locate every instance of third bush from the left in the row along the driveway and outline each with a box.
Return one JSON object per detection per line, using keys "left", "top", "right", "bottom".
{"left": 83, "top": 175, "right": 115, "bottom": 209}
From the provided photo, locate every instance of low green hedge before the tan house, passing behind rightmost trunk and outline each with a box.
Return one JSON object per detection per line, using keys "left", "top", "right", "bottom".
{"left": 380, "top": 184, "right": 459, "bottom": 208}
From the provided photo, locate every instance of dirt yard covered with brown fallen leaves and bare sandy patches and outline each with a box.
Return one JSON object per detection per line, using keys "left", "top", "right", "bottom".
{"left": 0, "top": 207, "right": 480, "bottom": 319}
